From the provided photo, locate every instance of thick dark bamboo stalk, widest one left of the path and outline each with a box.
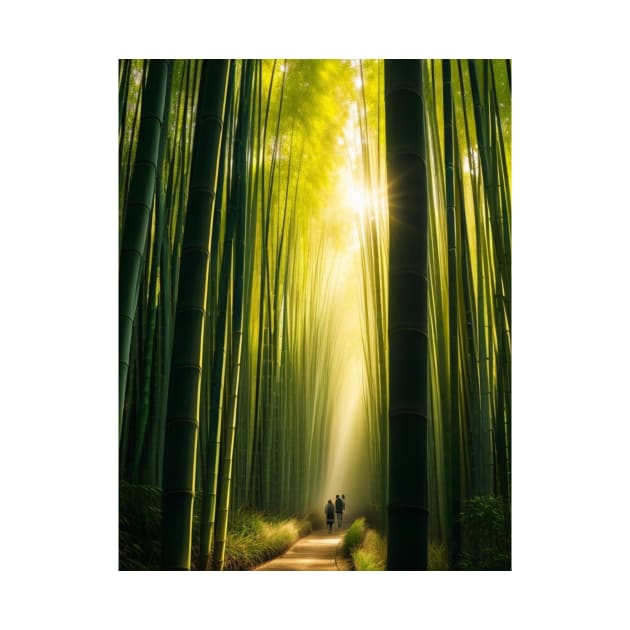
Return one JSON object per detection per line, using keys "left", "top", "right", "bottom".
{"left": 162, "top": 61, "right": 228, "bottom": 570}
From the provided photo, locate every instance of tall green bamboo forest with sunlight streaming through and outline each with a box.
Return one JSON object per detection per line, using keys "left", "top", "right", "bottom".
{"left": 118, "top": 59, "right": 512, "bottom": 571}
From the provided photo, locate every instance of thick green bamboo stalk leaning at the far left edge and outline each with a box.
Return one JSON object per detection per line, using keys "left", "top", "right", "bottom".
{"left": 118, "top": 60, "right": 168, "bottom": 434}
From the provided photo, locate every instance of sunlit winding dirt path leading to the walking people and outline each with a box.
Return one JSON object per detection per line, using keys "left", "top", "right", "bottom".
{"left": 254, "top": 519, "right": 352, "bottom": 571}
